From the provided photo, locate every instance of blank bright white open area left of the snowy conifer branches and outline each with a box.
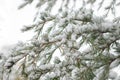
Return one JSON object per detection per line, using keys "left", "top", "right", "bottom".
{"left": 0, "top": 0, "right": 36, "bottom": 52}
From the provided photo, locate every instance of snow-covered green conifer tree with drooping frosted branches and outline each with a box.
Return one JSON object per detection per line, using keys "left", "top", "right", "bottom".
{"left": 2, "top": 0, "right": 120, "bottom": 80}
